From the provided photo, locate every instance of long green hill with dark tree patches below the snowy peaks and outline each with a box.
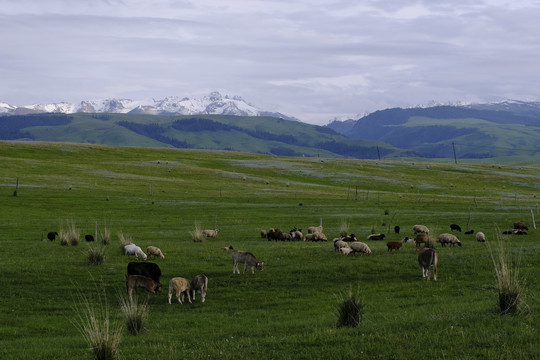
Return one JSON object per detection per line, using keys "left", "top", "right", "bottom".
{"left": 0, "top": 113, "right": 415, "bottom": 159}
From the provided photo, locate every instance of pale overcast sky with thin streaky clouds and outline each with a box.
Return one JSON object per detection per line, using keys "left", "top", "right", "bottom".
{"left": 0, "top": 0, "right": 540, "bottom": 125}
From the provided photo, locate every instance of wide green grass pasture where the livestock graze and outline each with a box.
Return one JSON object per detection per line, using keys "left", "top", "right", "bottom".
{"left": 0, "top": 142, "right": 540, "bottom": 359}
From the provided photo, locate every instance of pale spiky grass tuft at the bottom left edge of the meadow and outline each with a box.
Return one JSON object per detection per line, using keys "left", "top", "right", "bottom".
{"left": 73, "top": 290, "right": 122, "bottom": 360}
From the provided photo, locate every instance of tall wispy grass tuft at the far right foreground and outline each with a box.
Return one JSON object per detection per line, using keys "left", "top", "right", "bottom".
{"left": 489, "top": 238, "right": 528, "bottom": 315}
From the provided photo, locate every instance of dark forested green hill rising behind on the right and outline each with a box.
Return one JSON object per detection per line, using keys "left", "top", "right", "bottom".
{"left": 328, "top": 106, "right": 540, "bottom": 159}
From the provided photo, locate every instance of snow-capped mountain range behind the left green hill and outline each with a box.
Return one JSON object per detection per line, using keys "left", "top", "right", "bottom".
{"left": 0, "top": 91, "right": 297, "bottom": 120}
